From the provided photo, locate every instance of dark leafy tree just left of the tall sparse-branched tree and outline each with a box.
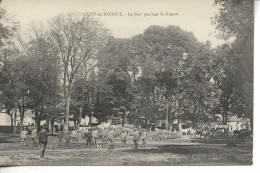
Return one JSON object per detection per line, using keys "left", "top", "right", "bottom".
{"left": 27, "top": 37, "right": 61, "bottom": 131}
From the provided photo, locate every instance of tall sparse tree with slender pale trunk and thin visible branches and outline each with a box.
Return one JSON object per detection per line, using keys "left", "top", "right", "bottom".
{"left": 50, "top": 14, "right": 107, "bottom": 133}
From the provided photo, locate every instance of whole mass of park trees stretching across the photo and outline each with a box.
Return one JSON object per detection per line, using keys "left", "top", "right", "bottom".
{"left": 0, "top": 0, "right": 253, "bottom": 132}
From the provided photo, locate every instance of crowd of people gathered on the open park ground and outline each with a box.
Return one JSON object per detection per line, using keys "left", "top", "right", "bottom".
{"left": 21, "top": 126, "right": 148, "bottom": 158}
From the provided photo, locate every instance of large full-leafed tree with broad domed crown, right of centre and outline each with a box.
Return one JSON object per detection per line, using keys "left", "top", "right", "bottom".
{"left": 132, "top": 26, "right": 217, "bottom": 128}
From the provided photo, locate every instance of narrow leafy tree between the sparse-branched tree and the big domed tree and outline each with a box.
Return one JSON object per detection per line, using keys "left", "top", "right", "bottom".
{"left": 97, "top": 37, "right": 133, "bottom": 125}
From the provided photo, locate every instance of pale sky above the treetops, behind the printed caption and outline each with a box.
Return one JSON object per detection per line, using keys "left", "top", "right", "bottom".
{"left": 1, "top": 0, "right": 224, "bottom": 47}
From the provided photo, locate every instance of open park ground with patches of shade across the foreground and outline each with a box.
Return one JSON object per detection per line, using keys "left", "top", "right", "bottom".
{"left": 0, "top": 134, "right": 253, "bottom": 166}
